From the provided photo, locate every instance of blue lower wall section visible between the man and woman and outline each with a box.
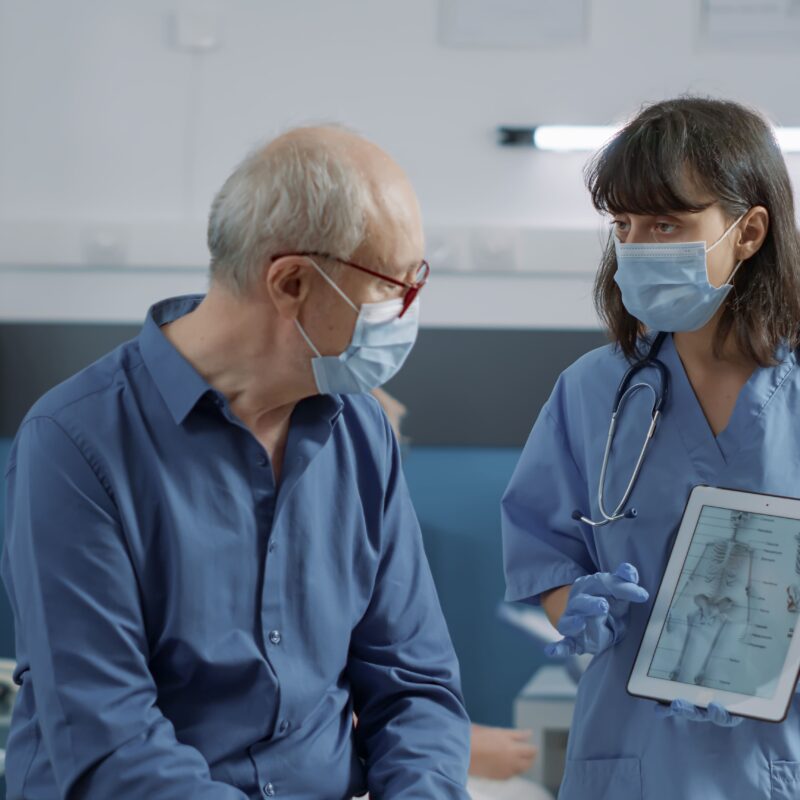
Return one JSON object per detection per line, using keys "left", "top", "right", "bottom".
{"left": 405, "top": 447, "right": 544, "bottom": 725}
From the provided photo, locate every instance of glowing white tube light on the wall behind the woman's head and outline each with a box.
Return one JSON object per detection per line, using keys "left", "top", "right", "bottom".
{"left": 497, "top": 125, "right": 800, "bottom": 153}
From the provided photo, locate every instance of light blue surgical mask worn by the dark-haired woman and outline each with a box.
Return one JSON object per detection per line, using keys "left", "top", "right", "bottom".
{"left": 614, "top": 214, "right": 744, "bottom": 333}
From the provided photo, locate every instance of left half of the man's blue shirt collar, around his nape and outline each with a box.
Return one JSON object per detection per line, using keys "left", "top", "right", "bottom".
{"left": 139, "top": 295, "right": 214, "bottom": 425}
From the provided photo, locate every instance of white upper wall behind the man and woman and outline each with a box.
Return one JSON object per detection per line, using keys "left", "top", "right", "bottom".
{"left": 0, "top": 0, "right": 800, "bottom": 327}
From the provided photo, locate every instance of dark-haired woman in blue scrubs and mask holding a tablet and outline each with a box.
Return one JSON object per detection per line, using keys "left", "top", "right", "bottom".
{"left": 503, "top": 98, "right": 800, "bottom": 800}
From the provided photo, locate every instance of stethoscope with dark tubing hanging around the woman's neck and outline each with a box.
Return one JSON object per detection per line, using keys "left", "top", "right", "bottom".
{"left": 572, "top": 333, "right": 669, "bottom": 528}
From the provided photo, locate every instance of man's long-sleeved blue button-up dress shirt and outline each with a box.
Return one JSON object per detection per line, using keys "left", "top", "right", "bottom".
{"left": 2, "top": 297, "right": 469, "bottom": 800}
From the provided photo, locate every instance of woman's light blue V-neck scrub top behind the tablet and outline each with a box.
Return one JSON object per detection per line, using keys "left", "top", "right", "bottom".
{"left": 503, "top": 337, "right": 800, "bottom": 800}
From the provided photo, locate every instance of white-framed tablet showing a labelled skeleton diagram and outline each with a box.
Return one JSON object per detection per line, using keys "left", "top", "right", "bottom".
{"left": 628, "top": 486, "right": 800, "bottom": 722}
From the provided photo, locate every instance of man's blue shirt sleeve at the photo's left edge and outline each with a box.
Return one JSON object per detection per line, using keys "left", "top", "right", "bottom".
{"left": 3, "top": 417, "right": 247, "bottom": 800}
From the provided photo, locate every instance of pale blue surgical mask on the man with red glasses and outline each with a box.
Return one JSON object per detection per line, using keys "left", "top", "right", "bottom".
{"left": 295, "top": 261, "right": 419, "bottom": 394}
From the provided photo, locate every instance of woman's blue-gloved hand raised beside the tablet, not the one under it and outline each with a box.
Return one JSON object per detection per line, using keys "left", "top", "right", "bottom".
{"left": 545, "top": 564, "right": 650, "bottom": 657}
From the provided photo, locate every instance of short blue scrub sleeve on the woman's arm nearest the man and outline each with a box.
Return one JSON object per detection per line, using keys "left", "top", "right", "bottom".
{"left": 501, "top": 378, "right": 596, "bottom": 603}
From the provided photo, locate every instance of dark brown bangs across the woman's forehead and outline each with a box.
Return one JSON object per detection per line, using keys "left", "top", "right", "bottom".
{"left": 586, "top": 118, "right": 713, "bottom": 215}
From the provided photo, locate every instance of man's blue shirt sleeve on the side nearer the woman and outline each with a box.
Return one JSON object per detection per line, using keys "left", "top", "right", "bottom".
{"left": 348, "top": 410, "right": 470, "bottom": 800}
